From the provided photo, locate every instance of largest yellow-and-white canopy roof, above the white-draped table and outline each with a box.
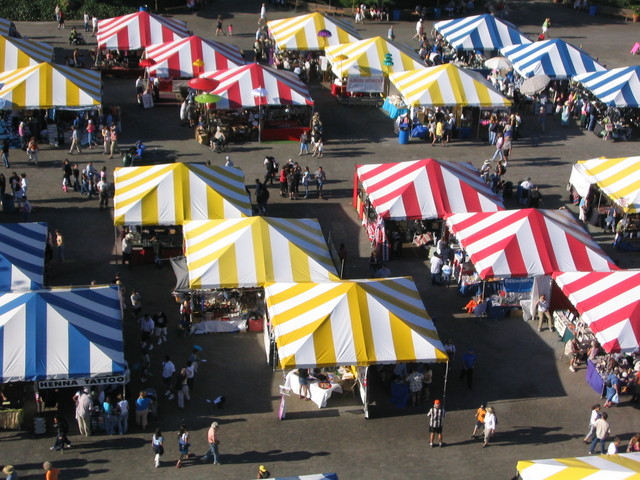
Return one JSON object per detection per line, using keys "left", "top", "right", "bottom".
{"left": 265, "top": 277, "right": 448, "bottom": 369}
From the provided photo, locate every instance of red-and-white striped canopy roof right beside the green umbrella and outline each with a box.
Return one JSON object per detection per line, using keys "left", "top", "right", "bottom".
{"left": 201, "top": 63, "right": 313, "bottom": 110}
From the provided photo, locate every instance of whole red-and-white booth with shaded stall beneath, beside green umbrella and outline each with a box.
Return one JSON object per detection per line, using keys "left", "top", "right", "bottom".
{"left": 198, "top": 63, "right": 313, "bottom": 141}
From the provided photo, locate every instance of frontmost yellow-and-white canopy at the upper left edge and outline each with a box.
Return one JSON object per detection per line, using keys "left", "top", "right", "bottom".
{"left": 0, "top": 62, "right": 102, "bottom": 110}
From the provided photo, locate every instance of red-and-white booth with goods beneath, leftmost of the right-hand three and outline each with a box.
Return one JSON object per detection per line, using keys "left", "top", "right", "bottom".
{"left": 353, "top": 159, "right": 504, "bottom": 258}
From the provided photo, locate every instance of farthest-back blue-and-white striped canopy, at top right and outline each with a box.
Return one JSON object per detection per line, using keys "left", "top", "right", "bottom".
{"left": 434, "top": 14, "right": 531, "bottom": 51}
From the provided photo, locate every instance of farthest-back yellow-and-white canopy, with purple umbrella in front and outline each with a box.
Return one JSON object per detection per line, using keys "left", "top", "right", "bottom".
{"left": 267, "top": 12, "right": 360, "bottom": 50}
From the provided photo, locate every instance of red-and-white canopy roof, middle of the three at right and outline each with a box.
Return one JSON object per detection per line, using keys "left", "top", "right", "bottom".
{"left": 447, "top": 208, "right": 617, "bottom": 278}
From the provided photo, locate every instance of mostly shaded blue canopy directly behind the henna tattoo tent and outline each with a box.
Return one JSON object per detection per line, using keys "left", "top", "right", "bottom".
{"left": 0, "top": 223, "right": 47, "bottom": 291}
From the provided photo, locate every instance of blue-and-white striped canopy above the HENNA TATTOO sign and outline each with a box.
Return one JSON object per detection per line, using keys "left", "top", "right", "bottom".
{"left": 0, "top": 286, "right": 125, "bottom": 383}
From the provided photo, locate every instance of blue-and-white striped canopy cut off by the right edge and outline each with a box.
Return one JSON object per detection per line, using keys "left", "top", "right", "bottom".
{"left": 574, "top": 65, "right": 640, "bottom": 108}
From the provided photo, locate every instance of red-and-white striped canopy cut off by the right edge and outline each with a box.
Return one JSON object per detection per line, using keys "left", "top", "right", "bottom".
{"left": 553, "top": 270, "right": 640, "bottom": 352}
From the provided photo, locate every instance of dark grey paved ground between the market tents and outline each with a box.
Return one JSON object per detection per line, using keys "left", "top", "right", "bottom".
{"left": 0, "top": 0, "right": 640, "bottom": 480}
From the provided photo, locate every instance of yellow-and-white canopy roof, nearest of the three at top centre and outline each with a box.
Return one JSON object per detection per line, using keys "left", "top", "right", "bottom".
{"left": 389, "top": 63, "right": 511, "bottom": 107}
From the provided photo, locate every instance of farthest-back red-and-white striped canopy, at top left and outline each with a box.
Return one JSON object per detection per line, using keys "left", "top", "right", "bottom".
{"left": 98, "top": 12, "right": 189, "bottom": 50}
